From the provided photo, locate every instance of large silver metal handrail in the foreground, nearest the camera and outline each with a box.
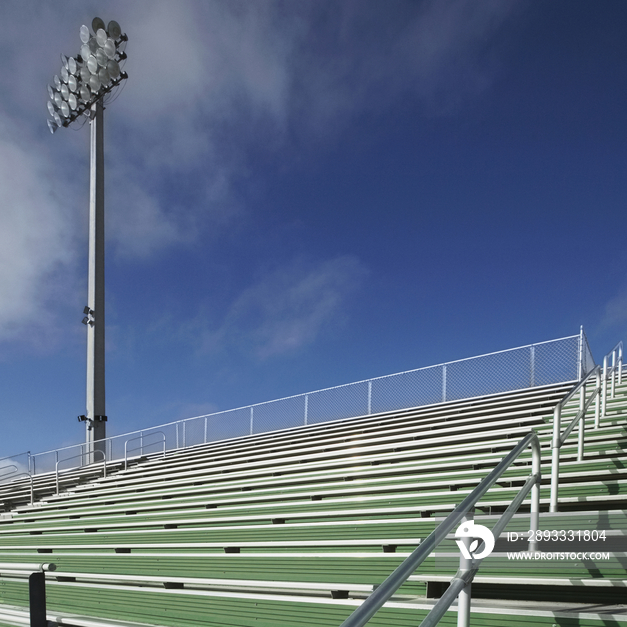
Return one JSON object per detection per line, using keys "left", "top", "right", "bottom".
{"left": 340, "top": 431, "right": 542, "bottom": 627}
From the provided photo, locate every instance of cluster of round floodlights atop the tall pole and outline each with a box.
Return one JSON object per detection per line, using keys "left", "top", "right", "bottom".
{"left": 48, "top": 17, "right": 128, "bottom": 133}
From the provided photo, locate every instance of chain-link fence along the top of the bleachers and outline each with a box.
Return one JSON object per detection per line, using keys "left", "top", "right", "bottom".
{"left": 27, "top": 329, "right": 595, "bottom": 480}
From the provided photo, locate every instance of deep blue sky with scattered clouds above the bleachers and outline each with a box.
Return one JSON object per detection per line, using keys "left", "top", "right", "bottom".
{"left": 0, "top": 0, "right": 627, "bottom": 462}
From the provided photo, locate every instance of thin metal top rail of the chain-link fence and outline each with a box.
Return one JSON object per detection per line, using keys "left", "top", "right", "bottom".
{"left": 25, "top": 334, "right": 581, "bottom": 457}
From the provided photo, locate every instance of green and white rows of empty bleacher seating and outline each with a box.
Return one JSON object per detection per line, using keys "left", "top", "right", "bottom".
{"left": 0, "top": 364, "right": 627, "bottom": 627}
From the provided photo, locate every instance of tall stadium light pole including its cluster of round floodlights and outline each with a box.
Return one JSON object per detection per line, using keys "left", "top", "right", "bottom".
{"left": 48, "top": 17, "right": 128, "bottom": 463}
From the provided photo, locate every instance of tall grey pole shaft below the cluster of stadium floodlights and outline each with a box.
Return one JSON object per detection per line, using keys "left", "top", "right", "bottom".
{"left": 86, "top": 100, "right": 107, "bottom": 463}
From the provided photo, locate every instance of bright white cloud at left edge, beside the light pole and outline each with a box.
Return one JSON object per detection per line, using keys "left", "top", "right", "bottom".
{"left": 0, "top": 114, "right": 75, "bottom": 344}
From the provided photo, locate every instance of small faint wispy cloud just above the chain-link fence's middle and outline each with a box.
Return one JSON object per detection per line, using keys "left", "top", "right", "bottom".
{"left": 193, "top": 255, "right": 368, "bottom": 360}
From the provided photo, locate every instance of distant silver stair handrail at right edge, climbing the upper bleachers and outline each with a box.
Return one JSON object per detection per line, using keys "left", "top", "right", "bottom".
{"left": 549, "top": 341, "right": 623, "bottom": 512}
